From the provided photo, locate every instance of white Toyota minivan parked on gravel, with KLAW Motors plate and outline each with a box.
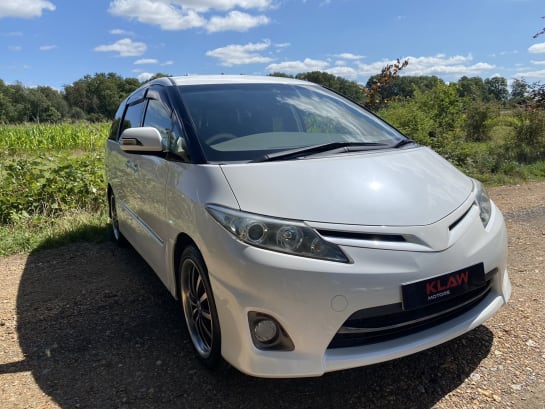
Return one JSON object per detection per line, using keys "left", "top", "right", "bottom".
{"left": 106, "top": 76, "right": 511, "bottom": 377}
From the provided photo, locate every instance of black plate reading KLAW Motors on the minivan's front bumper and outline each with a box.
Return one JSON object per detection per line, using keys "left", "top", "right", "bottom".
{"left": 401, "top": 263, "right": 485, "bottom": 310}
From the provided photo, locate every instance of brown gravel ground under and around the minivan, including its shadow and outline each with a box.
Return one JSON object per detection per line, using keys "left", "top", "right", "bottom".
{"left": 0, "top": 182, "right": 545, "bottom": 409}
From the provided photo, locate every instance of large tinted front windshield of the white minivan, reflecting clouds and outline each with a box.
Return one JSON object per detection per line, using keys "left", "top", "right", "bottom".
{"left": 180, "top": 84, "right": 405, "bottom": 162}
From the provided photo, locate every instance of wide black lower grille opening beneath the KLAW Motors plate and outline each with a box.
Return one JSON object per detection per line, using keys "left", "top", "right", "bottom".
{"left": 328, "top": 272, "right": 493, "bottom": 348}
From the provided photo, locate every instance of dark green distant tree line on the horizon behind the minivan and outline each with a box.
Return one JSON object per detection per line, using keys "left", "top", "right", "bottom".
{"left": 0, "top": 70, "right": 545, "bottom": 123}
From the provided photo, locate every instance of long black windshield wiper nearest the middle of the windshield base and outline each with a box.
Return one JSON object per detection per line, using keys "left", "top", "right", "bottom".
{"left": 252, "top": 142, "right": 388, "bottom": 162}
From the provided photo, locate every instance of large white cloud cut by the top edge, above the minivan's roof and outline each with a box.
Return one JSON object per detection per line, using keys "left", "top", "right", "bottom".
{"left": 108, "top": 0, "right": 273, "bottom": 33}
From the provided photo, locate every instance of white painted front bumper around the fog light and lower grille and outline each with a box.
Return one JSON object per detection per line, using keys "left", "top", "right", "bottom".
{"left": 202, "top": 202, "right": 511, "bottom": 377}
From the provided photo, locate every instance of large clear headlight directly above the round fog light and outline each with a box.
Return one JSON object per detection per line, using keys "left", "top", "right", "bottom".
{"left": 207, "top": 205, "right": 348, "bottom": 263}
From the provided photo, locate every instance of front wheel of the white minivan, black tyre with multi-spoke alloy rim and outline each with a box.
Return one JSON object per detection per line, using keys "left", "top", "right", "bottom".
{"left": 179, "top": 246, "right": 221, "bottom": 368}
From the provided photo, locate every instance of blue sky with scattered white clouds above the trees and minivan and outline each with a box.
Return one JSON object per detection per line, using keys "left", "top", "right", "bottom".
{"left": 0, "top": 0, "right": 545, "bottom": 90}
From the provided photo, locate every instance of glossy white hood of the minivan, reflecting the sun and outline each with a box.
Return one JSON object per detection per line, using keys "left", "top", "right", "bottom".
{"left": 222, "top": 147, "right": 473, "bottom": 226}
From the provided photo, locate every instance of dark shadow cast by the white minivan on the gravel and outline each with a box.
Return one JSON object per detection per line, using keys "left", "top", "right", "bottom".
{"left": 7, "top": 242, "right": 493, "bottom": 408}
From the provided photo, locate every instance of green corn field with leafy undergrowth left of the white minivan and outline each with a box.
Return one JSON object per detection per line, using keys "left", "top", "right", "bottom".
{"left": 0, "top": 122, "right": 109, "bottom": 226}
